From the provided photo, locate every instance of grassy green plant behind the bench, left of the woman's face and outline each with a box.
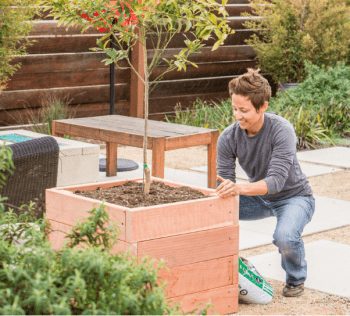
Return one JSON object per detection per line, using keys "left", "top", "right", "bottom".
{"left": 166, "top": 99, "right": 233, "bottom": 131}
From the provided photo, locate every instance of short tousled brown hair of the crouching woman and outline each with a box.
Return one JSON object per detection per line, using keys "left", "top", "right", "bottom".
{"left": 228, "top": 68, "right": 271, "bottom": 111}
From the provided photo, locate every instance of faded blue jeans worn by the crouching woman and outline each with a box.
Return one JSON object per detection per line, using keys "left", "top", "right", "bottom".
{"left": 239, "top": 196, "right": 315, "bottom": 285}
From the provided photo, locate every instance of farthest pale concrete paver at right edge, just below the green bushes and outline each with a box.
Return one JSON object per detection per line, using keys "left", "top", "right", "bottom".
{"left": 297, "top": 147, "right": 350, "bottom": 169}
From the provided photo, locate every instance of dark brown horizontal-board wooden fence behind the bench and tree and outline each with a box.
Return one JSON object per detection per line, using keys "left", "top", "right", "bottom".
{"left": 0, "top": 0, "right": 255, "bottom": 125}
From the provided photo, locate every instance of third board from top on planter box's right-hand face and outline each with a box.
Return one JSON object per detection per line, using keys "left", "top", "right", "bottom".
{"left": 158, "top": 256, "right": 238, "bottom": 298}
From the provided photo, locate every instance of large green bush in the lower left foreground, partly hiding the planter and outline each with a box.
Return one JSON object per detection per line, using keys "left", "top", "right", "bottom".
{"left": 0, "top": 207, "right": 176, "bottom": 315}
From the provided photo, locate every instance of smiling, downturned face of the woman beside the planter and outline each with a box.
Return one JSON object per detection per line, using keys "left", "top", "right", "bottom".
{"left": 231, "top": 94, "right": 268, "bottom": 136}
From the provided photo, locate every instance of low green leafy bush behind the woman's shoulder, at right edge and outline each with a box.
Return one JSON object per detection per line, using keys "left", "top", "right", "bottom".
{"left": 270, "top": 64, "right": 350, "bottom": 147}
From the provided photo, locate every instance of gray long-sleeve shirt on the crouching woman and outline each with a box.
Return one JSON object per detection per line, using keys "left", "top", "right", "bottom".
{"left": 217, "top": 113, "right": 312, "bottom": 201}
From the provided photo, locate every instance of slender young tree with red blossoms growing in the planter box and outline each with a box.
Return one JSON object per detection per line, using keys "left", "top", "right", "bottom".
{"left": 46, "top": 0, "right": 233, "bottom": 194}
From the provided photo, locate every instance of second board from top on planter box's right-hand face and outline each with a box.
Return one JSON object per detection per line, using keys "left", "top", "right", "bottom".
{"left": 137, "top": 226, "right": 238, "bottom": 267}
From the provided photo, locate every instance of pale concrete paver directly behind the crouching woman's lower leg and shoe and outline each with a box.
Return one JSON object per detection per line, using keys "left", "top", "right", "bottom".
{"left": 248, "top": 240, "right": 350, "bottom": 297}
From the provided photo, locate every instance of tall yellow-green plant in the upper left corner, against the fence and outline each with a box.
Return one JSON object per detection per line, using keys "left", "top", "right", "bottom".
{"left": 0, "top": 0, "right": 40, "bottom": 91}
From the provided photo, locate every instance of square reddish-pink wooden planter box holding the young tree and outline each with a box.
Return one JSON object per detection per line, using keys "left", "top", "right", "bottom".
{"left": 46, "top": 179, "right": 238, "bottom": 314}
